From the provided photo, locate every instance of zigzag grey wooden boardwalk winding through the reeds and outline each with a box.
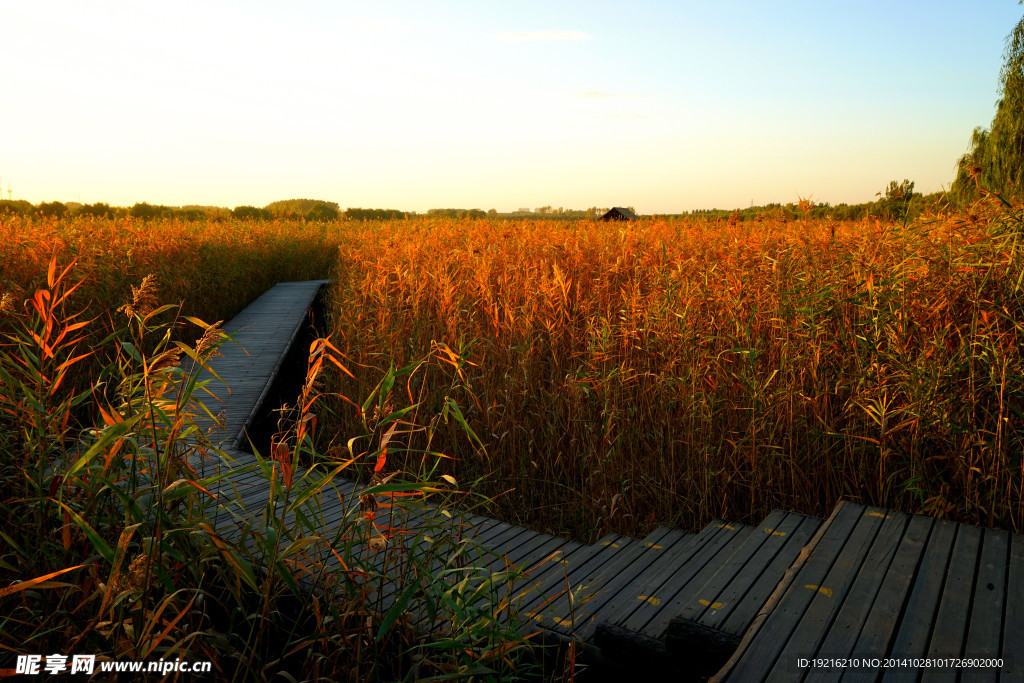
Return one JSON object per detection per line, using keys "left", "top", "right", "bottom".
{"left": 192, "top": 281, "right": 1024, "bottom": 681}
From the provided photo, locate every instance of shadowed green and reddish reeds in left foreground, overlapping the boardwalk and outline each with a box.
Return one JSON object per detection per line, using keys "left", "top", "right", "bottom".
{"left": 0, "top": 259, "right": 528, "bottom": 681}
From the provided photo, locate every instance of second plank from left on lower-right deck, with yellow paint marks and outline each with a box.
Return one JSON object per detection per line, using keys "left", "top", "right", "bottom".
{"left": 772, "top": 508, "right": 892, "bottom": 676}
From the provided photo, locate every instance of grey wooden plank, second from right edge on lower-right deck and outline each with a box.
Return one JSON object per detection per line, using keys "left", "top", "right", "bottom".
{"left": 961, "top": 528, "right": 1007, "bottom": 683}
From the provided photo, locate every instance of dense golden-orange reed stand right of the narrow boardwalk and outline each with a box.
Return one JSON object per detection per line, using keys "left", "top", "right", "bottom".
{"left": 321, "top": 199, "right": 1024, "bottom": 540}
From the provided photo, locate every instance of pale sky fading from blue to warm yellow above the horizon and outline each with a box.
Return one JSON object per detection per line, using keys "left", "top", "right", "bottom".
{"left": 0, "top": 0, "right": 1024, "bottom": 213}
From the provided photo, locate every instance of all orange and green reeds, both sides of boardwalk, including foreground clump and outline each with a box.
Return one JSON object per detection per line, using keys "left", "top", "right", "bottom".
{"left": 0, "top": 205, "right": 1024, "bottom": 680}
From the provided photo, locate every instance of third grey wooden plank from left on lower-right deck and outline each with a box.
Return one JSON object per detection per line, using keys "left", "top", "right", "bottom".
{"left": 798, "top": 513, "right": 912, "bottom": 682}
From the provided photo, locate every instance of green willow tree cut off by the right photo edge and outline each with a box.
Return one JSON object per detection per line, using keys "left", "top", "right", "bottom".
{"left": 952, "top": 7, "right": 1024, "bottom": 198}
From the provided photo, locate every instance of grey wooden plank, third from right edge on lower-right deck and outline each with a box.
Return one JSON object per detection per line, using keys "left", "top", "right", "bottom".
{"left": 922, "top": 524, "right": 981, "bottom": 681}
